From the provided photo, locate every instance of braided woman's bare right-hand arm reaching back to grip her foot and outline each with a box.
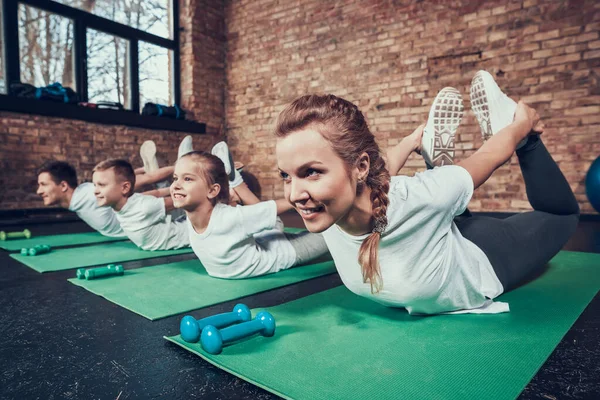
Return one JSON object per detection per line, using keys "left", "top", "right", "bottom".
{"left": 457, "top": 101, "right": 544, "bottom": 189}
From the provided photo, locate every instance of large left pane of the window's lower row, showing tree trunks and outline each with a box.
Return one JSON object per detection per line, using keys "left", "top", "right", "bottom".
{"left": 18, "top": 4, "right": 75, "bottom": 90}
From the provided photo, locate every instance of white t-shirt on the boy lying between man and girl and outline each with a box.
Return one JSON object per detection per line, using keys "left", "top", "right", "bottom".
{"left": 115, "top": 193, "right": 190, "bottom": 250}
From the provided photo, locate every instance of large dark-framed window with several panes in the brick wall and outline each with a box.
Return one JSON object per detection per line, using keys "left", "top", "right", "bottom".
{"left": 0, "top": 0, "right": 181, "bottom": 112}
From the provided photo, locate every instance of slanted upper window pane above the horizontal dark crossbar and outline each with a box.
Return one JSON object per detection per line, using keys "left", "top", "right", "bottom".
{"left": 58, "top": 0, "right": 173, "bottom": 38}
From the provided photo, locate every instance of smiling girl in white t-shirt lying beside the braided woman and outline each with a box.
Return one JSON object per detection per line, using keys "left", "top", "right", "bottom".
{"left": 171, "top": 149, "right": 328, "bottom": 279}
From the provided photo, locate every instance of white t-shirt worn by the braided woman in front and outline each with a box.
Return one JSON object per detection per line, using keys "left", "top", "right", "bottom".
{"left": 323, "top": 166, "right": 508, "bottom": 314}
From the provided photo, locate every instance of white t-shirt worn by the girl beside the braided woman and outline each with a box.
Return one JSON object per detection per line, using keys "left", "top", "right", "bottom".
{"left": 188, "top": 200, "right": 296, "bottom": 279}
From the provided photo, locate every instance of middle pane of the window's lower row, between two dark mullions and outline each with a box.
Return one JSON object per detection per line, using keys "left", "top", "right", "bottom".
{"left": 87, "top": 29, "right": 130, "bottom": 107}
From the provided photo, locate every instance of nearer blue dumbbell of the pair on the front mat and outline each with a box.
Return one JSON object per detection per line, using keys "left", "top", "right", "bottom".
{"left": 200, "top": 311, "right": 275, "bottom": 354}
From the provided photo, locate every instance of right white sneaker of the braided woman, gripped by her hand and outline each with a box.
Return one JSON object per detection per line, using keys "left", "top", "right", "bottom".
{"left": 470, "top": 71, "right": 527, "bottom": 149}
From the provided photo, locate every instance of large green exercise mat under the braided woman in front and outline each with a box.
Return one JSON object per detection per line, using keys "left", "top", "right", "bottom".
{"left": 166, "top": 252, "right": 600, "bottom": 400}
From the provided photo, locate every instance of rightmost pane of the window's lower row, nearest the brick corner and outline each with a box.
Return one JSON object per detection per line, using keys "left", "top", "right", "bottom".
{"left": 139, "top": 42, "right": 173, "bottom": 107}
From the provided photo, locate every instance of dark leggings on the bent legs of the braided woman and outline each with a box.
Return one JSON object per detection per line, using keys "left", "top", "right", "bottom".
{"left": 455, "top": 135, "right": 579, "bottom": 291}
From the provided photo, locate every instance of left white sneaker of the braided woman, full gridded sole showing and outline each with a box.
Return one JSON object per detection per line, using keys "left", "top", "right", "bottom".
{"left": 421, "top": 87, "right": 464, "bottom": 167}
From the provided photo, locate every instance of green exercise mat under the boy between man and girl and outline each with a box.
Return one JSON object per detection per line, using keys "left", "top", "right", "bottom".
{"left": 10, "top": 241, "right": 192, "bottom": 272}
